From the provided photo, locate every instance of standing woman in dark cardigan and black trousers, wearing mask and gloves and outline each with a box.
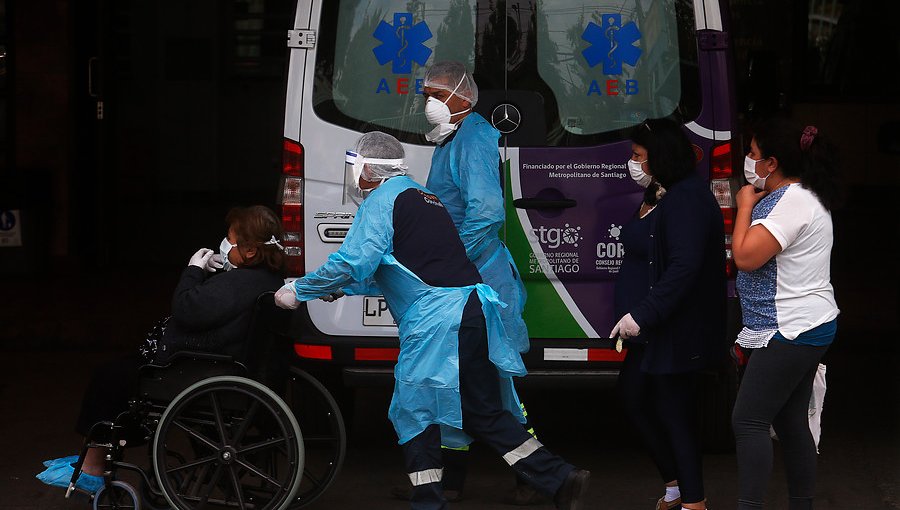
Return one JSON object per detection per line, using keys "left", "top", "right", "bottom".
{"left": 610, "top": 119, "right": 726, "bottom": 510}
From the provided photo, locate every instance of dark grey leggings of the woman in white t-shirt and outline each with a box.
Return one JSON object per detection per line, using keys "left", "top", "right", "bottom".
{"left": 732, "top": 339, "right": 828, "bottom": 510}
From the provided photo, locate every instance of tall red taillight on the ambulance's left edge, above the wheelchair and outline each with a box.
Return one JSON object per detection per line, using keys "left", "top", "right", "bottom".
{"left": 278, "top": 140, "right": 306, "bottom": 276}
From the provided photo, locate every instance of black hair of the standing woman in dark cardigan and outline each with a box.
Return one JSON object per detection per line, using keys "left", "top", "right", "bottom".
{"left": 631, "top": 119, "right": 697, "bottom": 205}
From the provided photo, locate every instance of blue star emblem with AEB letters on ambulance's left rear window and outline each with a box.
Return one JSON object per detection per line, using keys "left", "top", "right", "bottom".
{"left": 372, "top": 12, "right": 432, "bottom": 95}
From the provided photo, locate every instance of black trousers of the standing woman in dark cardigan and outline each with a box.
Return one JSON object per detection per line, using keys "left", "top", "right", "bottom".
{"left": 618, "top": 345, "right": 704, "bottom": 503}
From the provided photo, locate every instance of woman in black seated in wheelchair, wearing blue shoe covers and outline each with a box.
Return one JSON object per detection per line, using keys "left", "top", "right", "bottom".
{"left": 37, "top": 205, "right": 284, "bottom": 492}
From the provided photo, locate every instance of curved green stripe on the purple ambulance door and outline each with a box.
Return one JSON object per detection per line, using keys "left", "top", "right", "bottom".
{"left": 504, "top": 160, "right": 587, "bottom": 338}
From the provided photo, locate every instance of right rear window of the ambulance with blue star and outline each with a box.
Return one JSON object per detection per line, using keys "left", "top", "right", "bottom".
{"left": 537, "top": 0, "right": 696, "bottom": 139}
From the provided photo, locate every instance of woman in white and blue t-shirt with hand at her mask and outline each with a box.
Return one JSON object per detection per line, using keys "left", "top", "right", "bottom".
{"left": 732, "top": 119, "right": 839, "bottom": 510}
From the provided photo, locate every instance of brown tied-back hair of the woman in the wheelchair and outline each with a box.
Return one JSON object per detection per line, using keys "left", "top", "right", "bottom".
{"left": 225, "top": 205, "right": 284, "bottom": 273}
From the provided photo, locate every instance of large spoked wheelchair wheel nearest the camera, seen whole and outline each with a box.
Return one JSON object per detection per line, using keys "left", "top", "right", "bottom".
{"left": 152, "top": 376, "right": 304, "bottom": 510}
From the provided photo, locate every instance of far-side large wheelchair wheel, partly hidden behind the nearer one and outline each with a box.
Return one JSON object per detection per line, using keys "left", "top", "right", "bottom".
{"left": 284, "top": 367, "right": 347, "bottom": 508}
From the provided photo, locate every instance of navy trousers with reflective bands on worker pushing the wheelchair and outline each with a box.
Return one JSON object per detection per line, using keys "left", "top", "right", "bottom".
{"left": 403, "top": 292, "right": 574, "bottom": 510}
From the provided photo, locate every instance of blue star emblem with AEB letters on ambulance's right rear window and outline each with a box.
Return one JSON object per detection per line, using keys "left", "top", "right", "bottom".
{"left": 581, "top": 13, "right": 643, "bottom": 96}
